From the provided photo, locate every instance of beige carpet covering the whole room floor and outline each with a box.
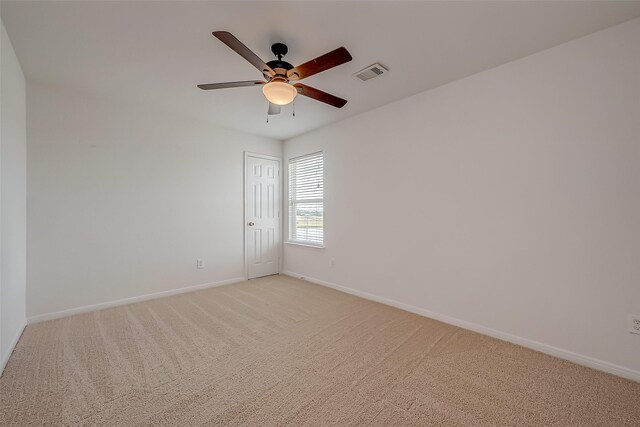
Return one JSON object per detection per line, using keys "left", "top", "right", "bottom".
{"left": 0, "top": 276, "right": 640, "bottom": 426}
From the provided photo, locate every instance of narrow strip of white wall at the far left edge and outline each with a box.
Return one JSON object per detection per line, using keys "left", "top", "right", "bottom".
{"left": 0, "top": 23, "right": 27, "bottom": 373}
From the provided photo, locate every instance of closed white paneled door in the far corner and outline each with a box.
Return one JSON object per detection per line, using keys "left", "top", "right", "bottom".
{"left": 244, "top": 154, "right": 281, "bottom": 279}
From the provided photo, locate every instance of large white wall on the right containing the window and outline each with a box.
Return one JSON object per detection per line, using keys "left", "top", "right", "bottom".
{"left": 284, "top": 19, "right": 640, "bottom": 379}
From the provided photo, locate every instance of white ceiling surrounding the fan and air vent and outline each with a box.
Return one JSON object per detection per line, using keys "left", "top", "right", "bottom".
{"left": 1, "top": 0, "right": 640, "bottom": 139}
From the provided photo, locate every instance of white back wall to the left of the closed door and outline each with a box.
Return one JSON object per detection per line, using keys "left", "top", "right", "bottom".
{"left": 27, "top": 82, "right": 282, "bottom": 319}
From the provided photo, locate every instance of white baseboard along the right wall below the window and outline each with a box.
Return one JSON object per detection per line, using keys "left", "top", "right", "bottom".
{"left": 282, "top": 271, "right": 640, "bottom": 382}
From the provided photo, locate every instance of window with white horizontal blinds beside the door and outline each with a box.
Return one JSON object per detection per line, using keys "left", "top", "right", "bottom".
{"left": 289, "top": 152, "right": 324, "bottom": 246}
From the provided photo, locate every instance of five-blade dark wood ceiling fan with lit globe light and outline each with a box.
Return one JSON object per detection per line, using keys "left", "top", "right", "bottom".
{"left": 198, "top": 31, "right": 352, "bottom": 114}
